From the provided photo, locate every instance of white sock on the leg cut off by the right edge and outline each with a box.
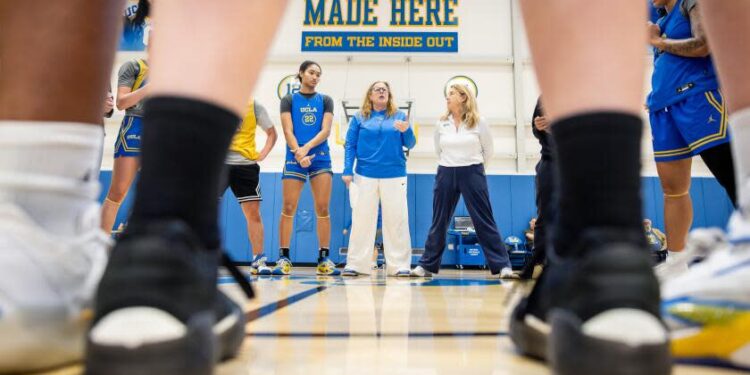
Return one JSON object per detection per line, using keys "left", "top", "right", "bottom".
{"left": 729, "top": 108, "right": 750, "bottom": 215}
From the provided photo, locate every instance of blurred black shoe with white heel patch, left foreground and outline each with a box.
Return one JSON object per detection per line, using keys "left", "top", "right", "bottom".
{"left": 86, "top": 220, "right": 247, "bottom": 375}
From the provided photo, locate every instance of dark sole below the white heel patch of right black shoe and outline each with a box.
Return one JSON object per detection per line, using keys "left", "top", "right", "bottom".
{"left": 547, "top": 309, "right": 672, "bottom": 375}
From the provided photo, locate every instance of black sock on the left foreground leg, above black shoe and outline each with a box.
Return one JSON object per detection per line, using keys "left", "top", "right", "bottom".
{"left": 128, "top": 96, "right": 240, "bottom": 249}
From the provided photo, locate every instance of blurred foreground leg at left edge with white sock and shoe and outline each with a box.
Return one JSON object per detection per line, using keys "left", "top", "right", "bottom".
{"left": 0, "top": 0, "right": 123, "bottom": 373}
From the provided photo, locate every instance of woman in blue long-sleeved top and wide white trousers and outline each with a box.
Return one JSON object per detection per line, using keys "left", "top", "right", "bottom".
{"left": 341, "top": 81, "right": 417, "bottom": 277}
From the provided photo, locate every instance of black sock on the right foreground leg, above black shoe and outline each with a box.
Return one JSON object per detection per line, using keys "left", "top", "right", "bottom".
{"left": 552, "top": 112, "right": 643, "bottom": 256}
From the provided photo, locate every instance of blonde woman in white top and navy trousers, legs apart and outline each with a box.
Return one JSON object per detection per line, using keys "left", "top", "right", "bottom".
{"left": 411, "top": 85, "right": 515, "bottom": 278}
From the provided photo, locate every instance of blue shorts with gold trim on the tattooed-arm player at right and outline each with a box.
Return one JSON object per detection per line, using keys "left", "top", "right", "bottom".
{"left": 649, "top": 90, "right": 730, "bottom": 162}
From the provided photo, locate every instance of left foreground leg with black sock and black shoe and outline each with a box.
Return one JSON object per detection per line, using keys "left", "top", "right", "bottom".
{"left": 87, "top": 0, "right": 286, "bottom": 374}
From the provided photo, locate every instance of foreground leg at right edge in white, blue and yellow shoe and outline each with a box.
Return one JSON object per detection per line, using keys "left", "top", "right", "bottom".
{"left": 662, "top": 0, "right": 750, "bottom": 369}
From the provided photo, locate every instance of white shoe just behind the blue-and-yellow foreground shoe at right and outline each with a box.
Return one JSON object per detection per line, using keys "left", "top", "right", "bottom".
{"left": 654, "top": 228, "right": 727, "bottom": 283}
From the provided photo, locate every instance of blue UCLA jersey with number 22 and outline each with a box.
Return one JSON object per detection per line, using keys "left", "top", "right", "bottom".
{"left": 287, "top": 92, "right": 331, "bottom": 160}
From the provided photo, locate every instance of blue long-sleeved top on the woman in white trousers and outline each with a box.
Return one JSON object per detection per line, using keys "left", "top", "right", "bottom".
{"left": 344, "top": 111, "right": 417, "bottom": 178}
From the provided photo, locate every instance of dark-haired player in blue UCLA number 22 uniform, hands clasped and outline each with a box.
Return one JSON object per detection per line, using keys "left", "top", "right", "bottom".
{"left": 273, "top": 60, "right": 340, "bottom": 275}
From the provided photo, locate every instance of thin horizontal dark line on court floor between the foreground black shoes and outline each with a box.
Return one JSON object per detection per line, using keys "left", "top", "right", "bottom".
{"left": 246, "top": 331, "right": 508, "bottom": 339}
